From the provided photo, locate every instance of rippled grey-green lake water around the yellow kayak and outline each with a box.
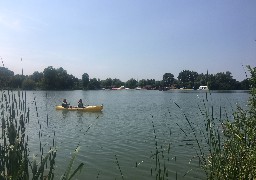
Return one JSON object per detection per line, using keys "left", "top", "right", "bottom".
{"left": 14, "top": 90, "right": 249, "bottom": 180}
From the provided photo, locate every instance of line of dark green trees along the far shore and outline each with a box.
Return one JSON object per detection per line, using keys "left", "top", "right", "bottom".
{"left": 0, "top": 66, "right": 249, "bottom": 90}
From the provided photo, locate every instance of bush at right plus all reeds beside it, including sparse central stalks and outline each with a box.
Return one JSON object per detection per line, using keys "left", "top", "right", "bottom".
{"left": 151, "top": 66, "right": 256, "bottom": 180}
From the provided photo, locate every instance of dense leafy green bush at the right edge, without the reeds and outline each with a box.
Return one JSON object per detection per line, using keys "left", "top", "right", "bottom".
{"left": 212, "top": 66, "right": 256, "bottom": 179}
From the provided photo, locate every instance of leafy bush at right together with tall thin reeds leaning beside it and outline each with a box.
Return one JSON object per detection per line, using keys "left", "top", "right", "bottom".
{"left": 176, "top": 66, "right": 256, "bottom": 179}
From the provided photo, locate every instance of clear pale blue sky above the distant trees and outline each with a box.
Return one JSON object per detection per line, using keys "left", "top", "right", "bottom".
{"left": 0, "top": 0, "right": 256, "bottom": 81}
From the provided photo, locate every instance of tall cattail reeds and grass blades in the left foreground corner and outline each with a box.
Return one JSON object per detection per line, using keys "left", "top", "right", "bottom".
{"left": 0, "top": 90, "right": 83, "bottom": 180}
